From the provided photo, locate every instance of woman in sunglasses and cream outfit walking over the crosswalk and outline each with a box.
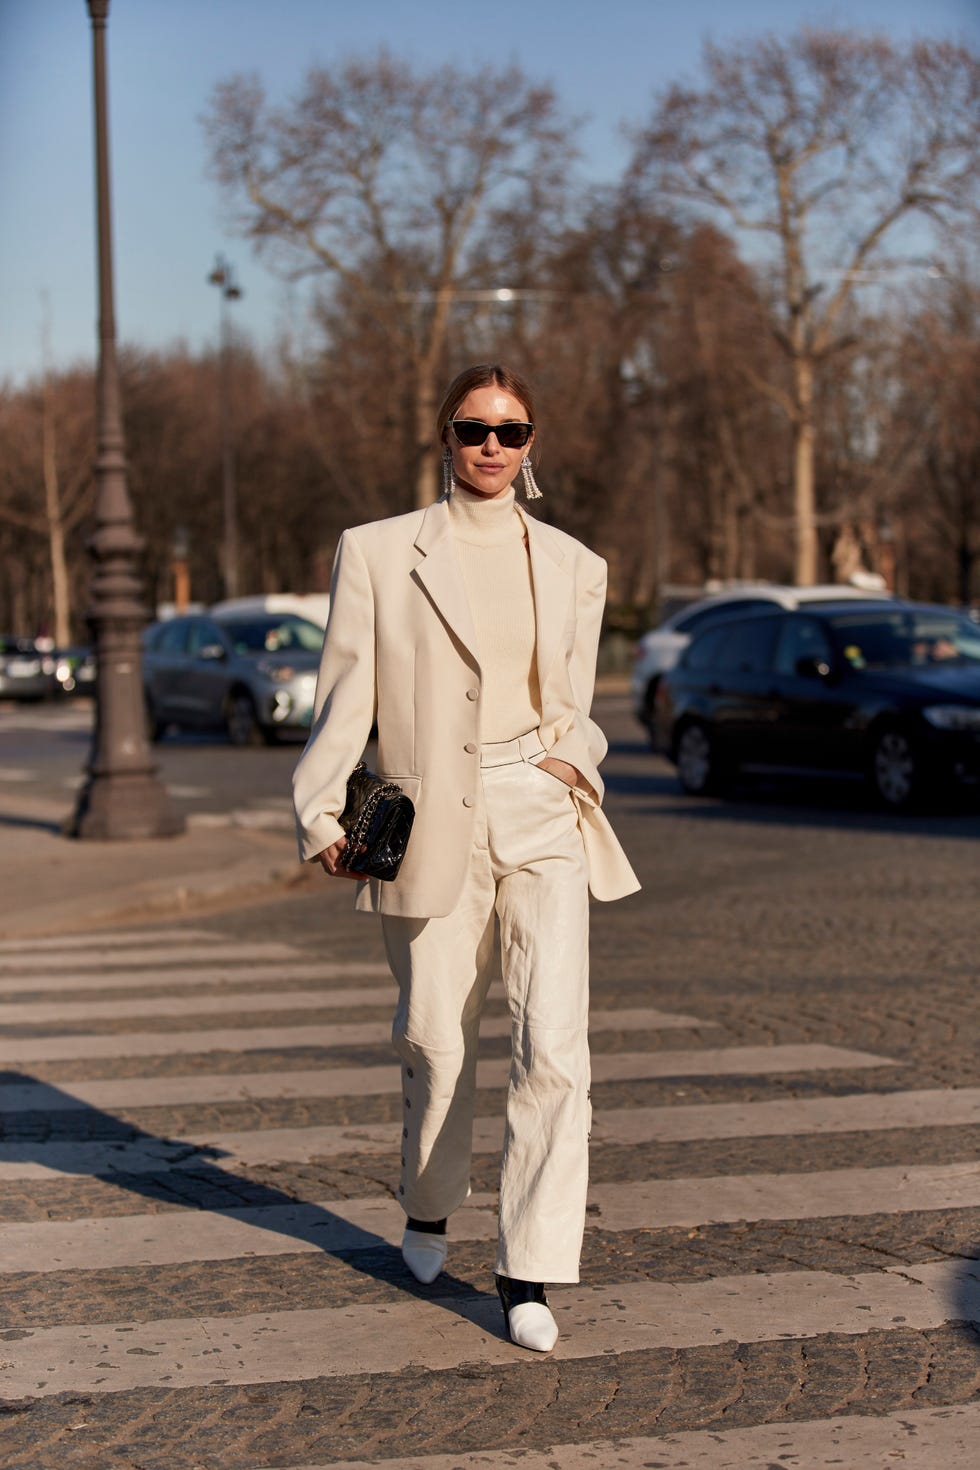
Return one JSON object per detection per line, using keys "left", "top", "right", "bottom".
{"left": 294, "top": 365, "right": 639, "bottom": 1352}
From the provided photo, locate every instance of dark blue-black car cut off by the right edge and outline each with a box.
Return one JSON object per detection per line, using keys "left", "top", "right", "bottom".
{"left": 655, "top": 601, "right": 980, "bottom": 810}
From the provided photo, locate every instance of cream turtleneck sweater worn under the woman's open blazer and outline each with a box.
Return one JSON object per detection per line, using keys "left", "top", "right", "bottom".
{"left": 450, "top": 485, "right": 541, "bottom": 742}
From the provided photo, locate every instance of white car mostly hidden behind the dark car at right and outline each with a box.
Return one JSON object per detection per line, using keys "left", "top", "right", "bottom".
{"left": 630, "top": 584, "right": 892, "bottom": 739}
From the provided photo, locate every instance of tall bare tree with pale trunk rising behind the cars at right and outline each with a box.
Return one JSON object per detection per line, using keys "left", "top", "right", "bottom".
{"left": 632, "top": 29, "right": 980, "bottom": 582}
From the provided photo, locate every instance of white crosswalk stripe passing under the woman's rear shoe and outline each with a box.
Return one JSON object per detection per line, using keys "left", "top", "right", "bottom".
{"left": 0, "top": 1164, "right": 980, "bottom": 1272}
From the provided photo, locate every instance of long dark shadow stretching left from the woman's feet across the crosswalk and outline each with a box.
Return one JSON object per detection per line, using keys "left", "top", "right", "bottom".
{"left": 0, "top": 1070, "right": 493, "bottom": 1336}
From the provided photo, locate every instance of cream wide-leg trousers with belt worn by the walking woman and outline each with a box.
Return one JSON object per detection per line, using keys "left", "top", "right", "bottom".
{"left": 382, "top": 732, "right": 591, "bottom": 1282}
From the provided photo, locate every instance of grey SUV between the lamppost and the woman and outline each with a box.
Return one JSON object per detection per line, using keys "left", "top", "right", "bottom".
{"left": 143, "top": 613, "right": 323, "bottom": 745}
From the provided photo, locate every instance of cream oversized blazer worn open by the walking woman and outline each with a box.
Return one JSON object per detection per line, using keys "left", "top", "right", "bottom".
{"left": 292, "top": 495, "right": 639, "bottom": 919}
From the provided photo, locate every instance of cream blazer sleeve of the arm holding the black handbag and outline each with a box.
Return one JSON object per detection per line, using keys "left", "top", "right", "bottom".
{"left": 292, "top": 531, "right": 378, "bottom": 863}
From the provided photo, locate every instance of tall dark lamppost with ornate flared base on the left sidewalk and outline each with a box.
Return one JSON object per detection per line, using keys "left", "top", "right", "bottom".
{"left": 66, "top": 0, "right": 184, "bottom": 839}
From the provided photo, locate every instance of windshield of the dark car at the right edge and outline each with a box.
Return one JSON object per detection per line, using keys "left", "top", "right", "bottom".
{"left": 832, "top": 609, "right": 980, "bottom": 669}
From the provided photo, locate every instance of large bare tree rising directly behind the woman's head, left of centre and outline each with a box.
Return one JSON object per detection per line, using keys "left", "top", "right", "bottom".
{"left": 204, "top": 53, "right": 572, "bottom": 504}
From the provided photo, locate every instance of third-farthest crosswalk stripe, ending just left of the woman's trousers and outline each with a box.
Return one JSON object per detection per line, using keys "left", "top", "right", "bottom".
{"left": 0, "top": 950, "right": 391, "bottom": 995}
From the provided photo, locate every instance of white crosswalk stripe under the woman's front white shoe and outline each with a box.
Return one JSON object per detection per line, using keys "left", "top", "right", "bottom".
{"left": 0, "top": 1261, "right": 980, "bottom": 1397}
